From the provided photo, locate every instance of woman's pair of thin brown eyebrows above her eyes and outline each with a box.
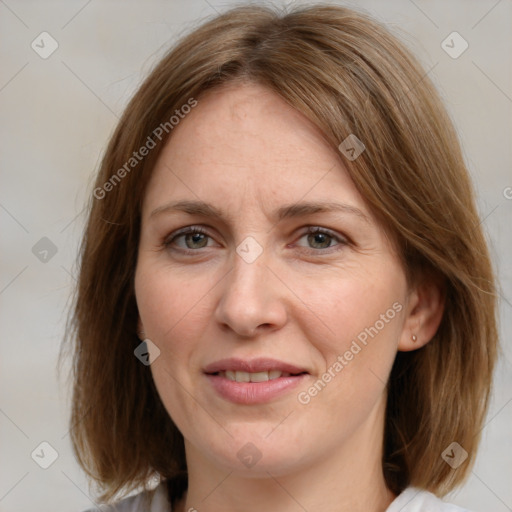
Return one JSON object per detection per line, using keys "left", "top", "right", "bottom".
{"left": 150, "top": 201, "right": 371, "bottom": 224}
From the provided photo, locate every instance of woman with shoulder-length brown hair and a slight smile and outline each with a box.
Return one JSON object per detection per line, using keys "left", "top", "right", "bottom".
{"left": 68, "top": 6, "right": 497, "bottom": 512}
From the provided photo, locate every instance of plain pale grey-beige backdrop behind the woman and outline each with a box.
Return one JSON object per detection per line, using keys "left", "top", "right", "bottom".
{"left": 0, "top": 0, "right": 512, "bottom": 512}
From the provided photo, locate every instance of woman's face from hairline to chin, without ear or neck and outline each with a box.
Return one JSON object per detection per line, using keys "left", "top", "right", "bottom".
{"left": 135, "top": 84, "right": 408, "bottom": 475}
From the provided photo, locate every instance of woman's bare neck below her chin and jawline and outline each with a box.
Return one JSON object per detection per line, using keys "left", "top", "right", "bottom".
{"left": 175, "top": 401, "right": 395, "bottom": 512}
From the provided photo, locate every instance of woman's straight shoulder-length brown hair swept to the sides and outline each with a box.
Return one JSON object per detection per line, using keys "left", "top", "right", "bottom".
{"left": 68, "top": 5, "right": 498, "bottom": 500}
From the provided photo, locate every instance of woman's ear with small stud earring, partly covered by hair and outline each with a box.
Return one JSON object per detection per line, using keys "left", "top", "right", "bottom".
{"left": 398, "top": 275, "right": 445, "bottom": 352}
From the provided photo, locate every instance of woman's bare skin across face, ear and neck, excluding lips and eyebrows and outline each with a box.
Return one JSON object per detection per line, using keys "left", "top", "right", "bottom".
{"left": 135, "top": 83, "right": 443, "bottom": 512}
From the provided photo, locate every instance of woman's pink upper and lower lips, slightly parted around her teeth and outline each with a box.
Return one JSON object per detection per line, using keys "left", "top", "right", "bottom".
{"left": 204, "top": 358, "right": 309, "bottom": 405}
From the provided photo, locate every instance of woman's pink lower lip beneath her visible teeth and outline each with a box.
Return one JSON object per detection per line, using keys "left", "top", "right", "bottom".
{"left": 206, "top": 374, "right": 307, "bottom": 405}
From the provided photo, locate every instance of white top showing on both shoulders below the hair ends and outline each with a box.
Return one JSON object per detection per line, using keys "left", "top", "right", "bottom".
{"left": 85, "top": 484, "right": 469, "bottom": 512}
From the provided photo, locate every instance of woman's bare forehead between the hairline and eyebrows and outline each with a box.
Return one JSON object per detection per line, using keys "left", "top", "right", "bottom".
{"left": 145, "top": 84, "right": 367, "bottom": 219}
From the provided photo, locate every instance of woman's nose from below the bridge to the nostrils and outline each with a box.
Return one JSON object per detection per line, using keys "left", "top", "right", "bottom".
{"left": 215, "top": 250, "right": 287, "bottom": 337}
